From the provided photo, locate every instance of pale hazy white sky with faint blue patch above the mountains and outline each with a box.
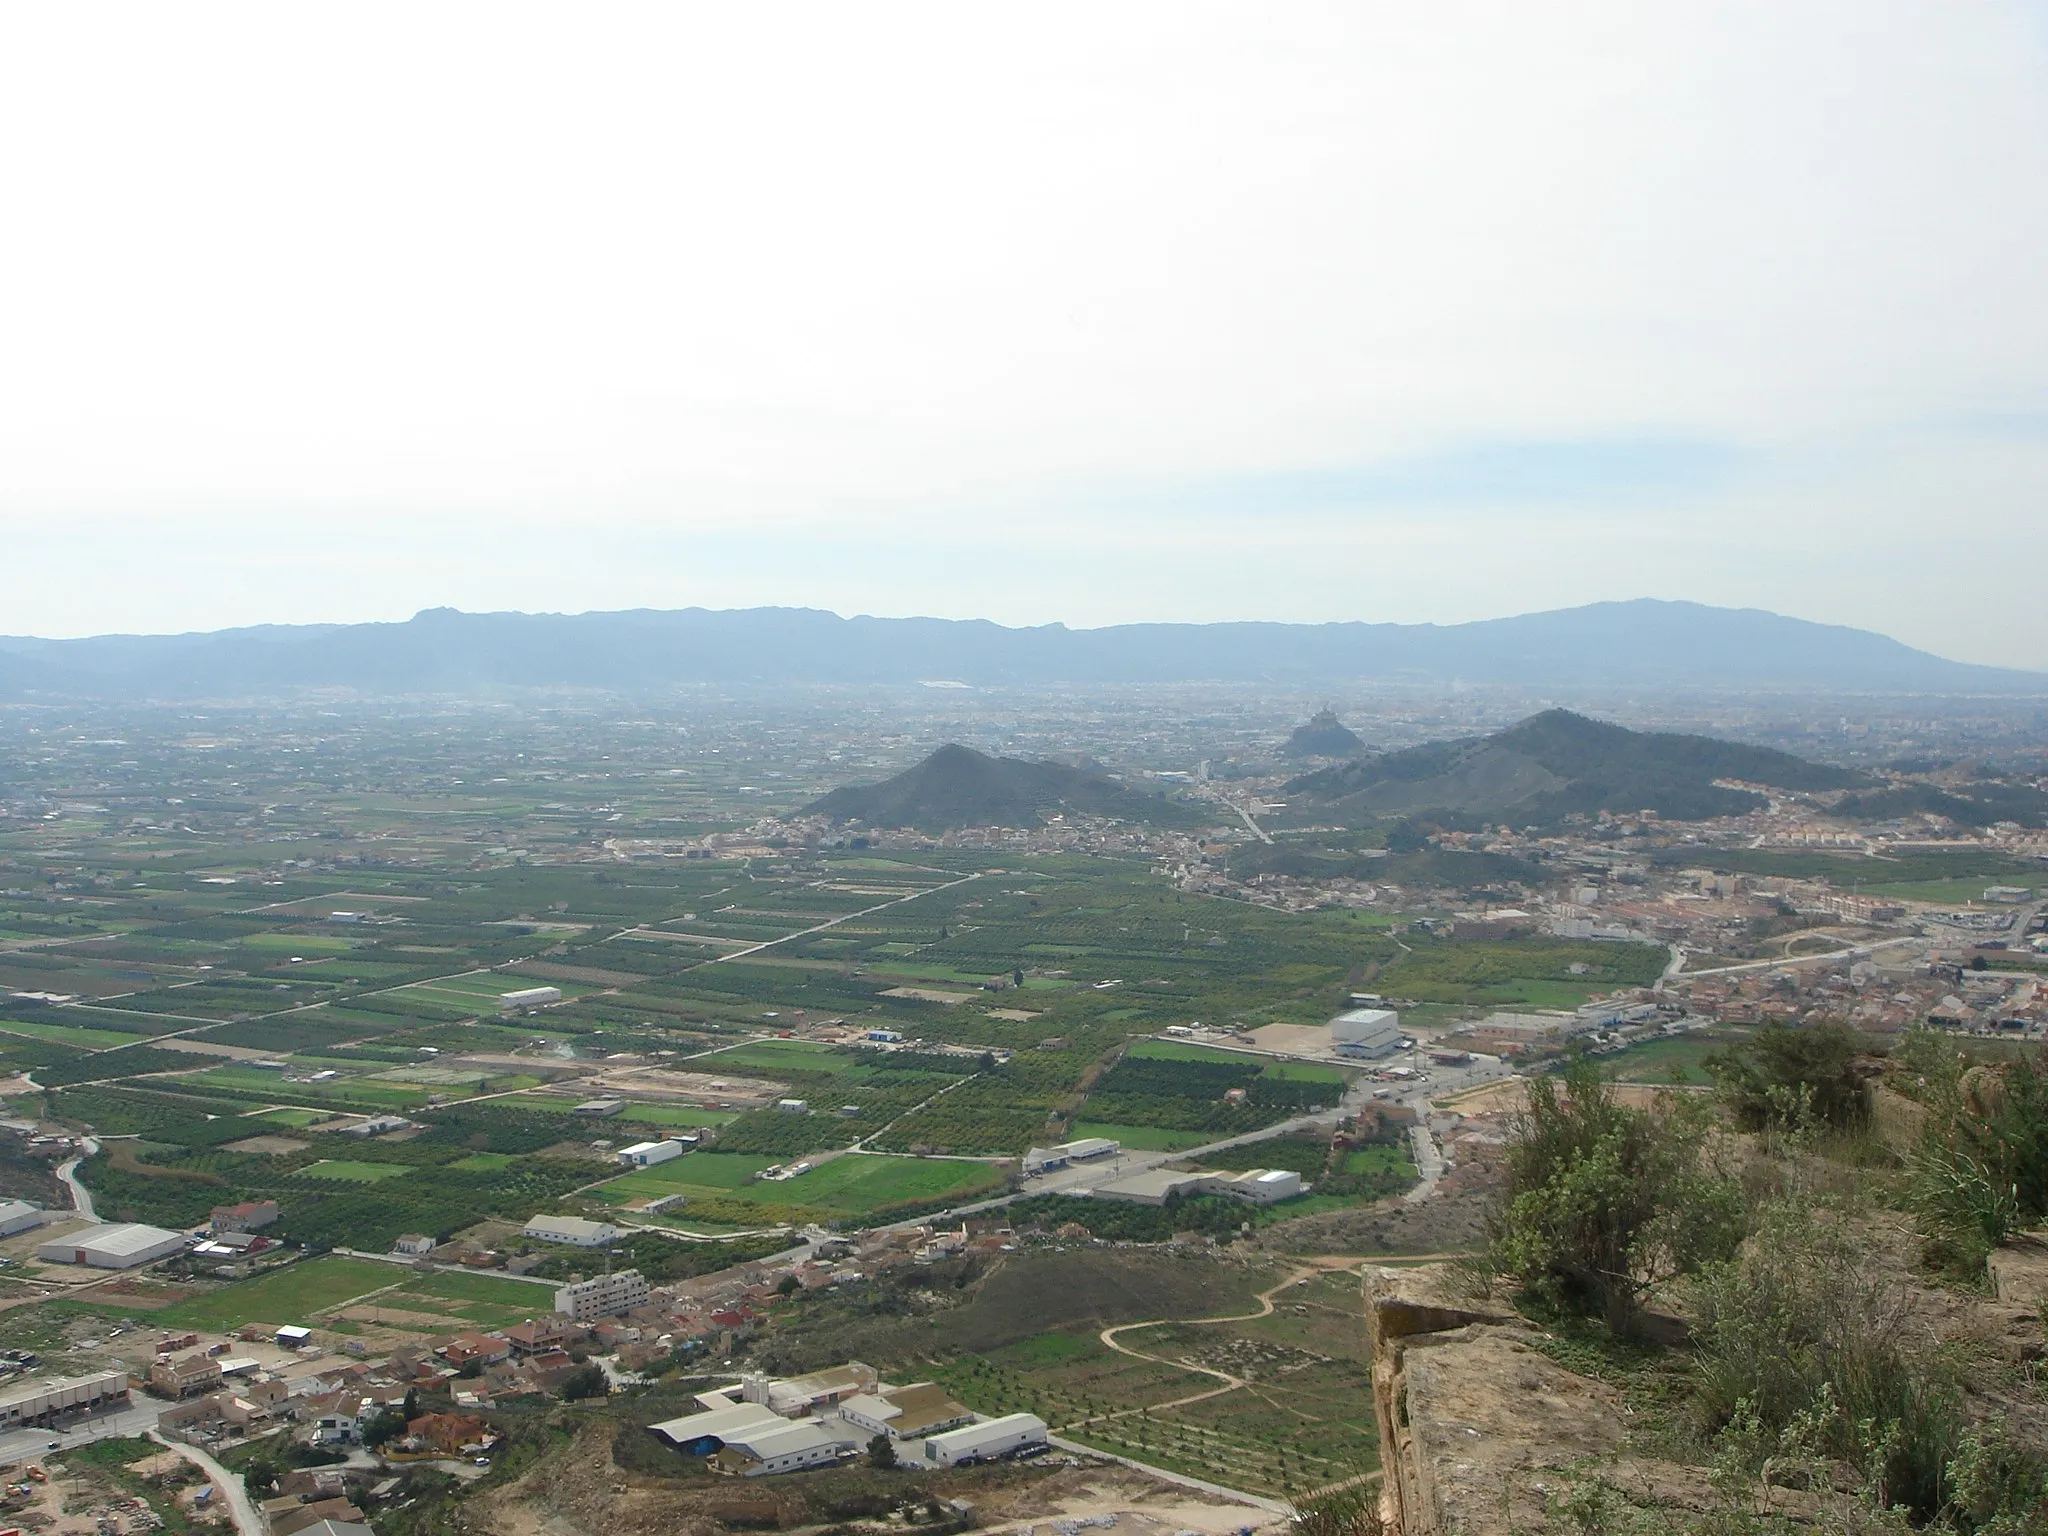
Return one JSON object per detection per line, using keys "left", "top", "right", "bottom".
{"left": 0, "top": 0, "right": 2048, "bottom": 668}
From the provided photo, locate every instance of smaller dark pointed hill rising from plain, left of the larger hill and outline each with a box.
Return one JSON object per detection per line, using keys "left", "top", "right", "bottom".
{"left": 799, "top": 745, "right": 1200, "bottom": 831}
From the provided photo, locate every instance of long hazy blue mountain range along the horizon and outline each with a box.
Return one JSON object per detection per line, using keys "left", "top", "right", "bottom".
{"left": 0, "top": 600, "right": 2048, "bottom": 698}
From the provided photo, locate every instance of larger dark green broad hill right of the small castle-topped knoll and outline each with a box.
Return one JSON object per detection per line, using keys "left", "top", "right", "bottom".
{"left": 1286, "top": 709, "right": 1876, "bottom": 825}
